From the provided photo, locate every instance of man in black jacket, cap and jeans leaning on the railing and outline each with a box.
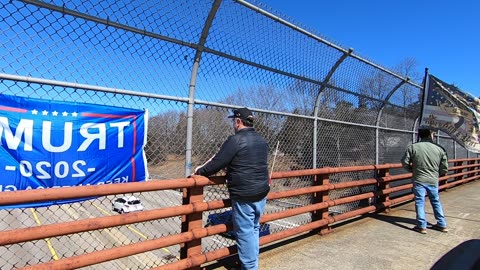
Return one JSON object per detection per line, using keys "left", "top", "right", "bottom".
{"left": 195, "top": 108, "right": 270, "bottom": 269}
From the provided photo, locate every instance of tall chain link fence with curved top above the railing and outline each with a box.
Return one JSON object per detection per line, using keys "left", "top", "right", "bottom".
{"left": 0, "top": 0, "right": 476, "bottom": 269}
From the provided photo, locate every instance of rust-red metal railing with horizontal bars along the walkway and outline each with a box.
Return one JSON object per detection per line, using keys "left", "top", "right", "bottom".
{"left": 0, "top": 158, "right": 480, "bottom": 269}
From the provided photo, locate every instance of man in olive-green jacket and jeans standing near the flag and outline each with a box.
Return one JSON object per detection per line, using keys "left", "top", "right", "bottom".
{"left": 401, "top": 128, "right": 448, "bottom": 234}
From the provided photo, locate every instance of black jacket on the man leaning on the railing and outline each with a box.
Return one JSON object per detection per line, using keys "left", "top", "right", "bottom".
{"left": 196, "top": 127, "right": 270, "bottom": 202}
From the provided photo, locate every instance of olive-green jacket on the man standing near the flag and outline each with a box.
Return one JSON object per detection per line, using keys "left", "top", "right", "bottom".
{"left": 401, "top": 139, "right": 448, "bottom": 185}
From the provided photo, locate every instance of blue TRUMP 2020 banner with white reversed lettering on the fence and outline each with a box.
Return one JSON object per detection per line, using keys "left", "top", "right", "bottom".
{"left": 0, "top": 95, "right": 148, "bottom": 208}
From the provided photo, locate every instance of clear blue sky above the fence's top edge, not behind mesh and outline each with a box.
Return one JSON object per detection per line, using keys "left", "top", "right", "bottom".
{"left": 258, "top": 0, "right": 480, "bottom": 97}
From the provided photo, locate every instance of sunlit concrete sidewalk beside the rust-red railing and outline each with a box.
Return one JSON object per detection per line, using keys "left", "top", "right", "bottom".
{"left": 260, "top": 181, "right": 480, "bottom": 270}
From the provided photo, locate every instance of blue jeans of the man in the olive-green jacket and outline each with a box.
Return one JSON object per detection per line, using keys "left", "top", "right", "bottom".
{"left": 413, "top": 182, "right": 447, "bottom": 228}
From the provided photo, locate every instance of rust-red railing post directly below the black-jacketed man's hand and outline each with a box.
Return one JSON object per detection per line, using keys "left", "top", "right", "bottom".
{"left": 180, "top": 181, "right": 203, "bottom": 270}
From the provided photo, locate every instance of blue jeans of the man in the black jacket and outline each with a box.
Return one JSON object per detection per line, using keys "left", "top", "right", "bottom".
{"left": 232, "top": 198, "right": 267, "bottom": 270}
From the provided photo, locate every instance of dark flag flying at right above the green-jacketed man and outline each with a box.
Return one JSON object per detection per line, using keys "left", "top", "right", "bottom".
{"left": 420, "top": 75, "right": 480, "bottom": 153}
